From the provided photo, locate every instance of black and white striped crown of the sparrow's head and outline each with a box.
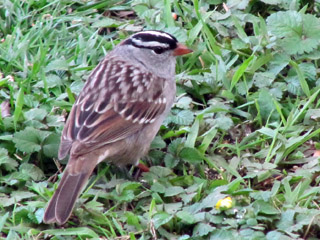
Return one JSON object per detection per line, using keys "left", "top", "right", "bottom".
{"left": 123, "top": 30, "right": 178, "bottom": 51}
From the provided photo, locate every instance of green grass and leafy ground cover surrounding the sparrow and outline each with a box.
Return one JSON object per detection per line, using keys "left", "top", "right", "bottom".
{"left": 0, "top": 0, "right": 320, "bottom": 240}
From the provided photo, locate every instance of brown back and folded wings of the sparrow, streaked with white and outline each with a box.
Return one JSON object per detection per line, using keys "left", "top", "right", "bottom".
{"left": 59, "top": 57, "right": 166, "bottom": 158}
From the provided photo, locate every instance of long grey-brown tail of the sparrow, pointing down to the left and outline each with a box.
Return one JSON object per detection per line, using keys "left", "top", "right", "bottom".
{"left": 43, "top": 159, "right": 95, "bottom": 224}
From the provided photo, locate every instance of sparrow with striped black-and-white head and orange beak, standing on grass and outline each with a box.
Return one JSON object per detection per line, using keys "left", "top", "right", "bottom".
{"left": 43, "top": 30, "right": 192, "bottom": 225}
